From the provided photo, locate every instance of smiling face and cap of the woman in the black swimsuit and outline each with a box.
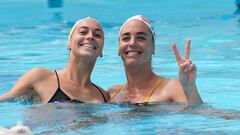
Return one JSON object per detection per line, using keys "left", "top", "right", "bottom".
{"left": 69, "top": 18, "right": 104, "bottom": 59}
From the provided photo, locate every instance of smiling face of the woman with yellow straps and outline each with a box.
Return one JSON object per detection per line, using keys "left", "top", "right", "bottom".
{"left": 119, "top": 20, "right": 154, "bottom": 65}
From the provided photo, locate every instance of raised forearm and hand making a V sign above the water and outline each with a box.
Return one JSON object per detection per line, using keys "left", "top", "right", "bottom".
{"left": 173, "top": 40, "right": 202, "bottom": 104}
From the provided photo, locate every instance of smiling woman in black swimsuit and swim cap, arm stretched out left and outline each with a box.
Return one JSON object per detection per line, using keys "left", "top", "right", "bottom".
{"left": 0, "top": 17, "right": 108, "bottom": 103}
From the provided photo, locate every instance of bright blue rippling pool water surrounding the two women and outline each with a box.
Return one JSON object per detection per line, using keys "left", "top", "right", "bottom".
{"left": 0, "top": 0, "right": 240, "bottom": 135}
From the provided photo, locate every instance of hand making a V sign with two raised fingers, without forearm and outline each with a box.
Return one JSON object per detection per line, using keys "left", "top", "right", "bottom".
{"left": 172, "top": 40, "right": 197, "bottom": 87}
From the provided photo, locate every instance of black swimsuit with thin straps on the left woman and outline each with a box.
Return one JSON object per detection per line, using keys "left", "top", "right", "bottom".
{"left": 48, "top": 71, "right": 107, "bottom": 103}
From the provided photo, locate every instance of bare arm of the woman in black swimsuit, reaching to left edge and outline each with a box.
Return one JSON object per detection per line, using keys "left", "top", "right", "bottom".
{"left": 0, "top": 68, "right": 45, "bottom": 100}
